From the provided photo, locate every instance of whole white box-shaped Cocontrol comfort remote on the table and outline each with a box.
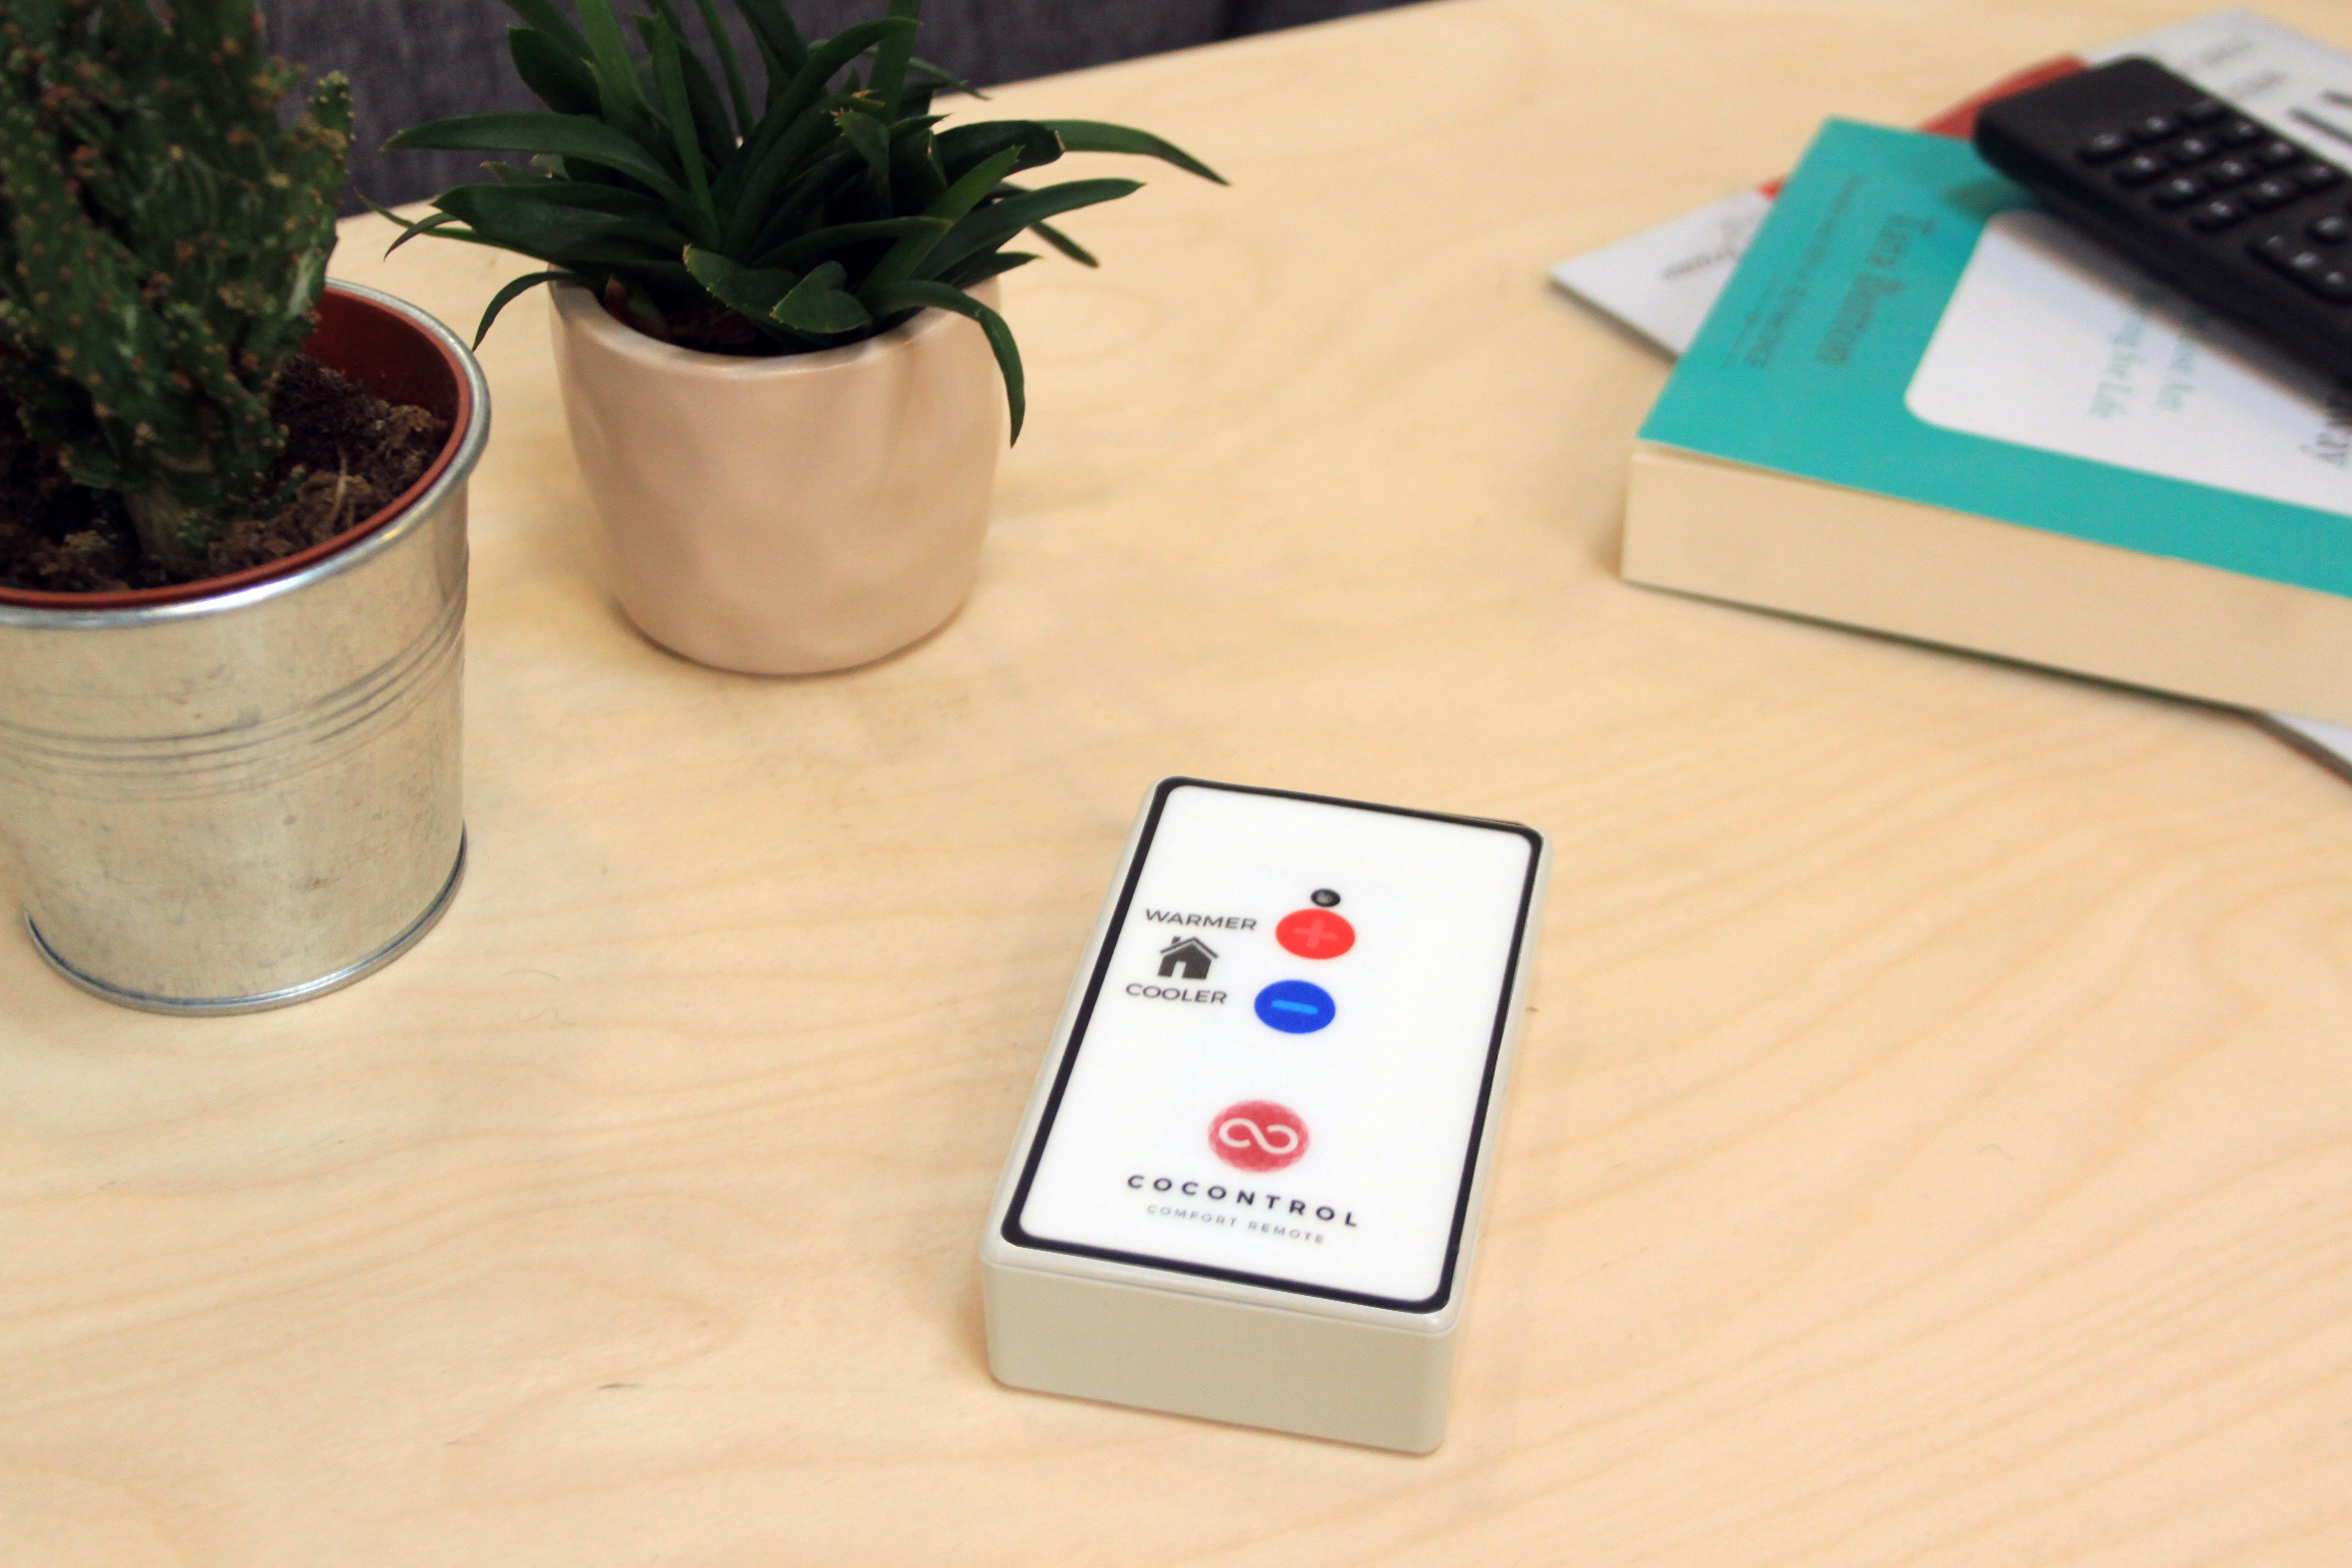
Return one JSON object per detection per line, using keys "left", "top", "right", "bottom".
{"left": 981, "top": 778, "right": 1548, "bottom": 1453}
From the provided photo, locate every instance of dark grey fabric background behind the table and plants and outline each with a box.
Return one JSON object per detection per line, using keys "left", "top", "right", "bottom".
{"left": 263, "top": 0, "right": 1399, "bottom": 211}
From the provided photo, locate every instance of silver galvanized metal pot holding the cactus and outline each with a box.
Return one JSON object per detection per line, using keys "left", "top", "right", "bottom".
{"left": 0, "top": 282, "right": 489, "bottom": 1013}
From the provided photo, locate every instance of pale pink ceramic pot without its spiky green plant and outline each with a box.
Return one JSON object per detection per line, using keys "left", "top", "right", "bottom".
{"left": 553, "top": 285, "right": 1007, "bottom": 675}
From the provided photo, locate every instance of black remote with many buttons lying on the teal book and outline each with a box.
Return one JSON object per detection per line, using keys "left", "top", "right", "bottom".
{"left": 1976, "top": 59, "right": 2352, "bottom": 376}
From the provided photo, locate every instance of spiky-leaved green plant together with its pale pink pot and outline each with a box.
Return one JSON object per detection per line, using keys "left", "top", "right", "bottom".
{"left": 388, "top": 0, "right": 1219, "bottom": 675}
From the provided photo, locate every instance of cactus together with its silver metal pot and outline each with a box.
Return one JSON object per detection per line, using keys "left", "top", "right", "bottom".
{"left": 0, "top": 0, "right": 489, "bottom": 1011}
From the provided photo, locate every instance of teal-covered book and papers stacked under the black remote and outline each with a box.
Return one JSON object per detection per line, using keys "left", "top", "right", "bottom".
{"left": 1555, "top": 12, "right": 2352, "bottom": 761}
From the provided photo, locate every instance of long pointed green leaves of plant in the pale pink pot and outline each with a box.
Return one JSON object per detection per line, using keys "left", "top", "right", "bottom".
{"left": 379, "top": 0, "right": 1223, "bottom": 437}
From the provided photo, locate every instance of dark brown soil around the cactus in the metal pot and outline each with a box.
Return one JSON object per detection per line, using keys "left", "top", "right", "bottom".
{"left": 0, "top": 355, "right": 449, "bottom": 592}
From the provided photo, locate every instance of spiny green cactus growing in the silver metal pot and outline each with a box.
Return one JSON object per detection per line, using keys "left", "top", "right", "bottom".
{"left": 0, "top": 0, "right": 350, "bottom": 571}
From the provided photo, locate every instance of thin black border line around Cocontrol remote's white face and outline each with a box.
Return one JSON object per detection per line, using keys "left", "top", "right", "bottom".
{"left": 1000, "top": 776, "right": 1543, "bottom": 1317}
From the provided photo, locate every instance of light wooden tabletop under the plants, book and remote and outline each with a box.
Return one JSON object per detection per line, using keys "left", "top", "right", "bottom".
{"left": 0, "top": 0, "right": 2352, "bottom": 1568}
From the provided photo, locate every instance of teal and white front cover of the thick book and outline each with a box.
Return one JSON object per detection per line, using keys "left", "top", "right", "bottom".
{"left": 1642, "top": 120, "right": 2352, "bottom": 595}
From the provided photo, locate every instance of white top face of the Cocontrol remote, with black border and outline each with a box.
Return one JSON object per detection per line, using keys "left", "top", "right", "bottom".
{"left": 1004, "top": 778, "right": 1543, "bottom": 1312}
